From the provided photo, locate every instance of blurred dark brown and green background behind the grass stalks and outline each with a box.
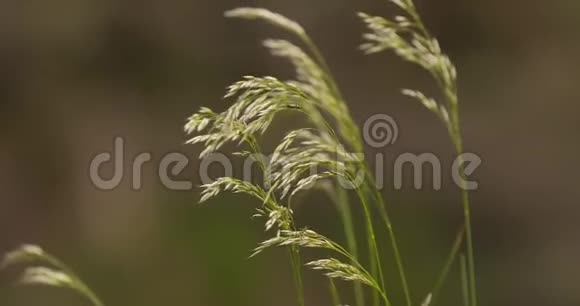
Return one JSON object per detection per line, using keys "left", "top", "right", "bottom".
{"left": 0, "top": 0, "right": 580, "bottom": 306}
